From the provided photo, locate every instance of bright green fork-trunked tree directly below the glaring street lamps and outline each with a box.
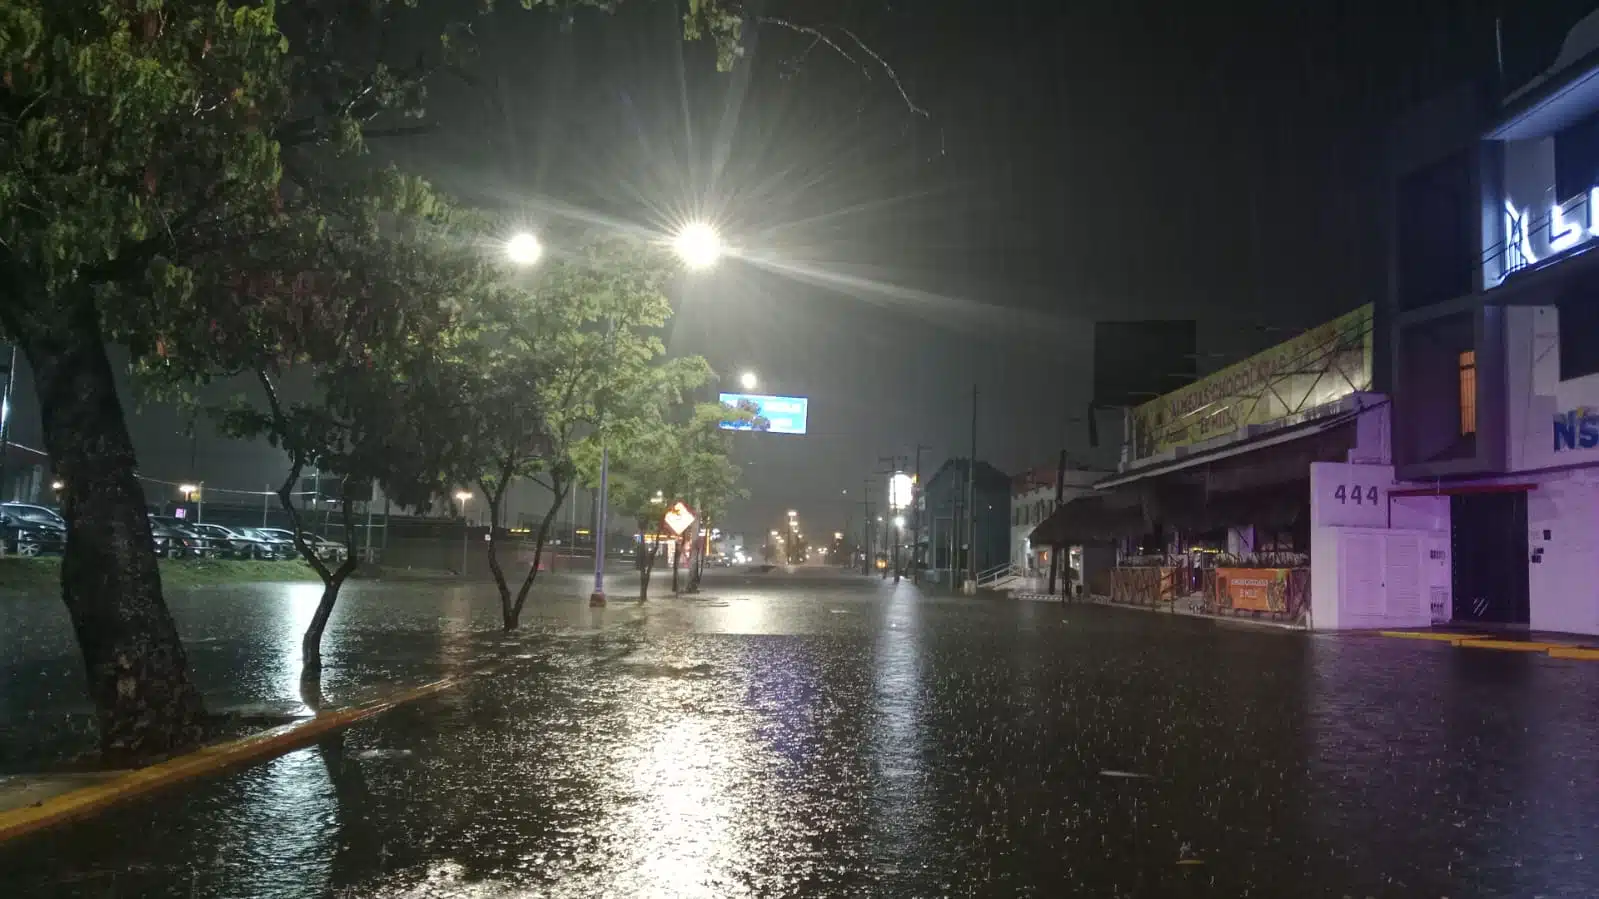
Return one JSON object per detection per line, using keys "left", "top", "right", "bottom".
{"left": 448, "top": 238, "right": 690, "bottom": 630}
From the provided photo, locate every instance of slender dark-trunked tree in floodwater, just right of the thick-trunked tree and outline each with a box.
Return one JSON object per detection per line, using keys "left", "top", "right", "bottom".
{"left": 204, "top": 187, "right": 497, "bottom": 675}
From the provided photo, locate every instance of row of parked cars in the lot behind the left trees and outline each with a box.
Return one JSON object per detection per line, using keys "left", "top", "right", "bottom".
{"left": 0, "top": 502, "right": 350, "bottom": 561}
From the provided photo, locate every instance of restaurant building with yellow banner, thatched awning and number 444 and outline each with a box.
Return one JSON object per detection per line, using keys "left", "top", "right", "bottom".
{"left": 1031, "top": 306, "right": 1407, "bottom": 629}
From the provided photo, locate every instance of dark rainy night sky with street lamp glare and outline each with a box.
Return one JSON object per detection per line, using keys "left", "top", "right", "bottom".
{"left": 3, "top": 0, "right": 1596, "bottom": 534}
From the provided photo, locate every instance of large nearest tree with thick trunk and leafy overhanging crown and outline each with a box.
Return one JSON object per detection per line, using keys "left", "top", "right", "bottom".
{"left": 0, "top": 0, "right": 901, "bottom": 757}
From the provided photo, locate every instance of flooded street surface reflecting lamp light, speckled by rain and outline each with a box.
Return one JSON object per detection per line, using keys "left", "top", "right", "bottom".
{"left": 0, "top": 576, "right": 1599, "bottom": 899}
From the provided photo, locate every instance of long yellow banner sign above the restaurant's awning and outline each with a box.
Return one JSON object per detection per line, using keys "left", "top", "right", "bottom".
{"left": 1132, "top": 304, "right": 1372, "bottom": 459}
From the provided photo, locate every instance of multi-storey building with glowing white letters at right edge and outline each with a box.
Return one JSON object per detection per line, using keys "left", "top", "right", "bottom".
{"left": 1386, "top": 16, "right": 1599, "bottom": 633}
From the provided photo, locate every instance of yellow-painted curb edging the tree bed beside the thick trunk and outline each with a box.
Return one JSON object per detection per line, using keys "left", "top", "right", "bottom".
{"left": 0, "top": 672, "right": 463, "bottom": 843}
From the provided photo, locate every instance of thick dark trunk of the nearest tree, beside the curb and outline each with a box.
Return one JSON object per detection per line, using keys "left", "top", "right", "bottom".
{"left": 19, "top": 318, "right": 205, "bottom": 760}
